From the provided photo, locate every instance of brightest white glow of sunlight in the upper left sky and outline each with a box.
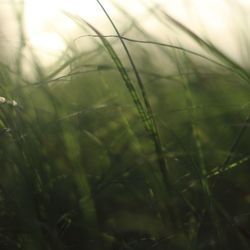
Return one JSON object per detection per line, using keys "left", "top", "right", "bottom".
{"left": 25, "top": 0, "right": 115, "bottom": 62}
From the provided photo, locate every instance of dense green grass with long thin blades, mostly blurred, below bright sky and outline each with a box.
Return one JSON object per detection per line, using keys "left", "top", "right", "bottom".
{"left": 0, "top": 1, "right": 250, "bottom": 250}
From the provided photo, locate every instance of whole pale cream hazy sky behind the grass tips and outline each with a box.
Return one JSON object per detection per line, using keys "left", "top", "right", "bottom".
{"left": 0, "top": 0, "right": 250, "bottom": 65}
